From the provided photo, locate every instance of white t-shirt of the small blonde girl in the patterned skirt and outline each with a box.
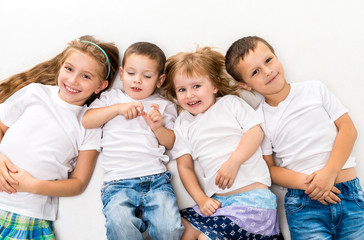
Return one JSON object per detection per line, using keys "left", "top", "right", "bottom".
{"left": 171, "top": 95, "right": 271, "bottom": 197}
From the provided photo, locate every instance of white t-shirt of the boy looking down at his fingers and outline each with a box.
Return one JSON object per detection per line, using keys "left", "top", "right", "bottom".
{"left": 90, "top": 89, "right": 177, "bottom": 181}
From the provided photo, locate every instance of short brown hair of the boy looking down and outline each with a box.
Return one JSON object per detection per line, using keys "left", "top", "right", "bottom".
{"left": 121, "top": 42, "right": 166, "bottom": 76}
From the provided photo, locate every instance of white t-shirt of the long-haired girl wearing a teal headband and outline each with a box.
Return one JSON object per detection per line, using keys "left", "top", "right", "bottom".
{"left": 0, "top": 84, "right": 101, "bottom": 221}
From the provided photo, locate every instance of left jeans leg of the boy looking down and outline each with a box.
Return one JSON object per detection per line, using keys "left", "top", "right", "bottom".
{"left": 102, "top": 179, "right": 146, "bottom": 240}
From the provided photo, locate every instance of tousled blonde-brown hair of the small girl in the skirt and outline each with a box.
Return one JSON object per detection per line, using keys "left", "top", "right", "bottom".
{"left": 162, "top": 47, "right": 241, "bottom": 109}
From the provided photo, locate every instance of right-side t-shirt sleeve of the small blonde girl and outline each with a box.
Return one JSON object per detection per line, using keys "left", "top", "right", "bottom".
{"left": 227, "top": 96, "right": 263, "bottom": 133}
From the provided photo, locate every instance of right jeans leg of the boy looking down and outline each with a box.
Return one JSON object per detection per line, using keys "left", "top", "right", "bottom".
{"left": 141, "top": 172, "right": 184, "bottom": 240}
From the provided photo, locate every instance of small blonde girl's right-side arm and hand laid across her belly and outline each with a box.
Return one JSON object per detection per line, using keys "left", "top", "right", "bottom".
{"left": 215, "top": 125, "right": 264, "bottom": 189}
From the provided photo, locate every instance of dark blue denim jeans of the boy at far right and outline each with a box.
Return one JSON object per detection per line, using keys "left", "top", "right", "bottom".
{"left": 285, "top": 178, "right": 364, "bottom": 240}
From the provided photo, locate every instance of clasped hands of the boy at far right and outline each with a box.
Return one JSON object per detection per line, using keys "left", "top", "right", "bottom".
{"left": 305, "top": 168, "right": 340, "bottom": 203}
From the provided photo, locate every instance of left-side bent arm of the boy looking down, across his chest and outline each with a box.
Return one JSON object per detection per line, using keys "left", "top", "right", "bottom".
{"left": 82, "top": 102, "right": 144, "bottom": 128}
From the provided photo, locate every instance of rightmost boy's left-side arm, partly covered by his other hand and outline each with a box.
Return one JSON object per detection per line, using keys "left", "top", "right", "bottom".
{"left": 263, "top": 155, "right": 341, "bottom": 205}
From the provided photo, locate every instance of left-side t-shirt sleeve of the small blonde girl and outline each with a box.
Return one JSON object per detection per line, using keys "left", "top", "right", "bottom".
{"left": 170, "top": 117, "right": 192, "bottom": 159}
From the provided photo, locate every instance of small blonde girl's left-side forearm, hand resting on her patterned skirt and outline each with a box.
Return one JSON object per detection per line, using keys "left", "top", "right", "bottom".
{"left": 177, "top": 154, "right": 221, "bottom": 216}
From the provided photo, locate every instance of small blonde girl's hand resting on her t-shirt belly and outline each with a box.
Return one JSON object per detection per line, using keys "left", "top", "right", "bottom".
{"left": 215, "top": 158, "right": 240, "bottom": 189}
